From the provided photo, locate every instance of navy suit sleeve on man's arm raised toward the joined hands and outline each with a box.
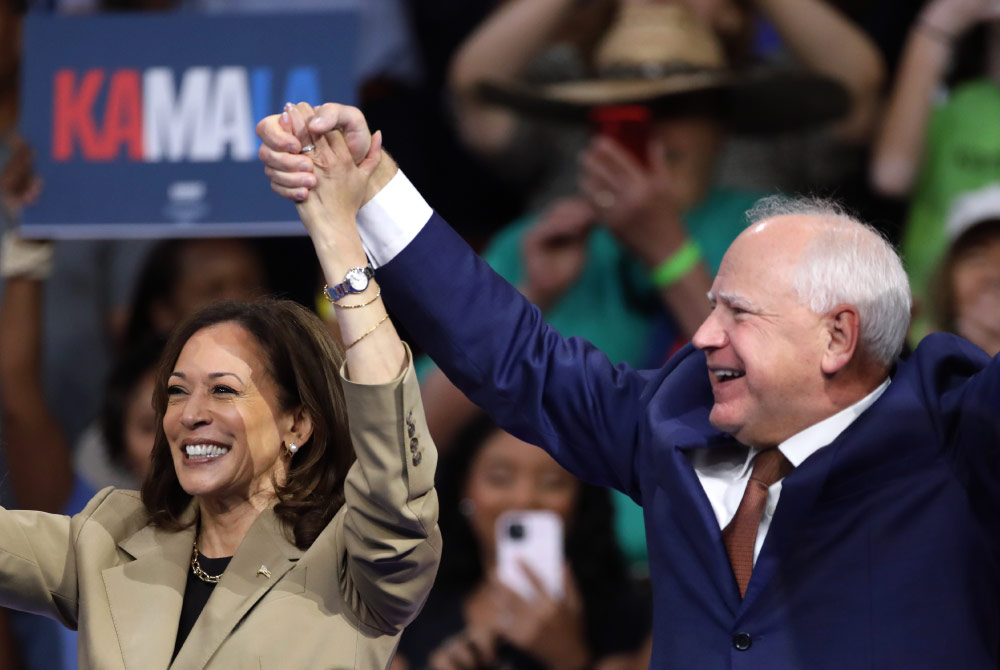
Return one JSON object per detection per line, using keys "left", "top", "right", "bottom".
{"left": 376, "top": 214, "right": 660, "bottom": 499}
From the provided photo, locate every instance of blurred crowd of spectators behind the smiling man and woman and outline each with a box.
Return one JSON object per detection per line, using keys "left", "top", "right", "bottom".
{"left": 0, "top": 0, "right": 1000, "bottom": 670}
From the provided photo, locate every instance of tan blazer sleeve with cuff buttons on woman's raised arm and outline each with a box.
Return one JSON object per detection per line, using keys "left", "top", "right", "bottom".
{"left": 340, "top": 347, "right": 441, "bottom": 634}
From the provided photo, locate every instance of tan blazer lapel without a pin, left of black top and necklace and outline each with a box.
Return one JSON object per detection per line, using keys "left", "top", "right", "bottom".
{"left": 102, "top": 506, "right": 195, "bottom": 670}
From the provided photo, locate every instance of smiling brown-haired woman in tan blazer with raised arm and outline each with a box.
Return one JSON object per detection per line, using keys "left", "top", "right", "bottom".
{"left": 0, "top": 107, "right": 441, "bottom": 670}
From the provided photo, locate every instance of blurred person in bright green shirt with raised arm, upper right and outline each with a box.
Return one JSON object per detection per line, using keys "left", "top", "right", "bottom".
{"left": 870, "top": 0, "right": 1000, "bottom": 343}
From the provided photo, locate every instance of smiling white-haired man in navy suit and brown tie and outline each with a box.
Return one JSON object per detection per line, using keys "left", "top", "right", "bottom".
{"left": 258, "top": 105, "right": 1000, "bottom": 670}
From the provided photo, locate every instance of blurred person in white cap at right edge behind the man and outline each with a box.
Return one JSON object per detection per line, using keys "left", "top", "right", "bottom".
{"left": 930, "top": 178, "right": 1000, "bottom": 356}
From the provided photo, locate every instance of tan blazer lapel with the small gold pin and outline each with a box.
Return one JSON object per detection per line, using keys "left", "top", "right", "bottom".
{"left": 171, "top": 506, "right": 302, "bottom": 668}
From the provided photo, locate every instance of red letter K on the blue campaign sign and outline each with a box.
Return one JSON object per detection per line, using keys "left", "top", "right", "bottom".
{"left": 52, "top": 69, "right": 104, "bottom": 161}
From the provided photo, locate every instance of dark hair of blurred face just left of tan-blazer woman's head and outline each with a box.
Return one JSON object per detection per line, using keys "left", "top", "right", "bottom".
{"left": 101, "top": 337, "right": 166, "bottom": 471}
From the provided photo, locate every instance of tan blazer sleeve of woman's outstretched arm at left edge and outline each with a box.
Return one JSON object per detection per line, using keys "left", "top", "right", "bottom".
{"left": 0, "top": 488, "right": 114, "bottom": 628}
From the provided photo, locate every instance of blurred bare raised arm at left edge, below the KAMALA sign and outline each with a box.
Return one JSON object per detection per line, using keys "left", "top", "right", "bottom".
{"left": 0, "top": 232, "right": 73, "bottom": 512}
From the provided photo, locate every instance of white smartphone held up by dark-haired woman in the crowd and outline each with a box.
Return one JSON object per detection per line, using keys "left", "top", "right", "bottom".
{"left": 496, "top": 510, "right": 563, "bottom": 600}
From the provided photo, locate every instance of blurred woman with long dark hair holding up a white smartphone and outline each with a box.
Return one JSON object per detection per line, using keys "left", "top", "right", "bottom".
{"left": 394, "top": 416, "right": 650, "bottom": 670}
